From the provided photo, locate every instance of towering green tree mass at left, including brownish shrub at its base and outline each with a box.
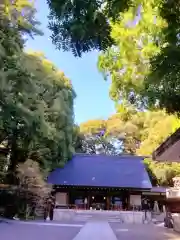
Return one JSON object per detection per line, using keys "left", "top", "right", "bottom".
{"left": 0, "top": 0, "right": 77, "bottom": 217}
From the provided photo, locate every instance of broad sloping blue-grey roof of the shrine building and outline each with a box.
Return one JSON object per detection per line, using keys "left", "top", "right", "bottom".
{"left": 48, "top": 155, "right": 152, "bottom": 189}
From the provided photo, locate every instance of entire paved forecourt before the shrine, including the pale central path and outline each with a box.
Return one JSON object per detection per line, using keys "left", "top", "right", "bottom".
{"left": 0, "top": 221, "right": 180, "bottom": 240}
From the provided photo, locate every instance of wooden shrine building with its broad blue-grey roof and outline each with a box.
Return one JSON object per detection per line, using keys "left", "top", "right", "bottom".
{"left": 48, "top": 154, "right": 165, "bottom": 210}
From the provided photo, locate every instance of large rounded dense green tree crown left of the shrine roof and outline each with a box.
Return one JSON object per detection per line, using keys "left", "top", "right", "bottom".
{"left": 0, "top": 51, "right": 75, "bottom": 178}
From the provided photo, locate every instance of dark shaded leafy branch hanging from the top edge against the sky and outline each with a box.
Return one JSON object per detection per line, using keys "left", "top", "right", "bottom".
{"left": 47, "top": 0, "right": 131, "bottom": 56}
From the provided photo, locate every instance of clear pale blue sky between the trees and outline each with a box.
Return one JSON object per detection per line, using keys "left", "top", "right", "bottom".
{"left": 26, "top": 0, "right": 115, "bottom": 123}
